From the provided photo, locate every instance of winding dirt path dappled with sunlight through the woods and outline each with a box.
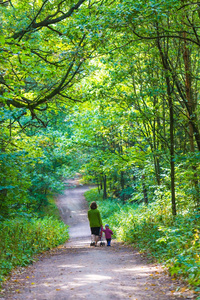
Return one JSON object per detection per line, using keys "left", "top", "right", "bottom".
{"left": 0, "top": 182, "right": 197, "bottom": 300}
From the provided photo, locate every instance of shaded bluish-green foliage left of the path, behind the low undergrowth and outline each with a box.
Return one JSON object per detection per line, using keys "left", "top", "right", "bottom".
{"left": 0, "top": 106, "right": 81, "bottom": 219}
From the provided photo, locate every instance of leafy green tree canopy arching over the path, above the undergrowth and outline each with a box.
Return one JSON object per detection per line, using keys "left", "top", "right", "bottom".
{"left": 0, "top": 0, "right": 200, "bottom": 215}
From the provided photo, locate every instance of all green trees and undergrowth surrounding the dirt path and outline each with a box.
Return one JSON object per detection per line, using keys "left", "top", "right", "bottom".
{"left": 0, "top": 0, "right": 200, "bottom": 291}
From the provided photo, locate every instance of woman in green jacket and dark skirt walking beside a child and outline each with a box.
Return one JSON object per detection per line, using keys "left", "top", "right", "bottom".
{"left": 88, "top": 201, "right": 102, "bottom": 246}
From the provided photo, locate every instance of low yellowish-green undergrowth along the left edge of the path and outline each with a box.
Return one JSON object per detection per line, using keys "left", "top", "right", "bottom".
{"left": 0, "top": 199, "right": 69, "bottom": 281}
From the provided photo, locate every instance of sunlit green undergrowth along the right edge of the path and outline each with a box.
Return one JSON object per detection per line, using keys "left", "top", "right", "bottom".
{"left": 85, "top": 189, "right": 200, "bottom": 291}
